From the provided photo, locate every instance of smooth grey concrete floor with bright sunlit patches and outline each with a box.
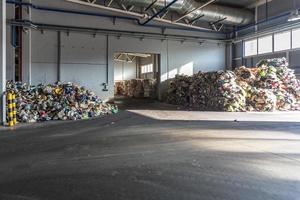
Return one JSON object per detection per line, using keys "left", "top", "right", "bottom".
{"left": 0, "top": 101, "right": 300, "bottom": 200}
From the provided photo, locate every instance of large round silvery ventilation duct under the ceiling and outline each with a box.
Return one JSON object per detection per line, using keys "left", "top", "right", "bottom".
{"left": 122, "top": 0, "right": 254, "bottom": 26}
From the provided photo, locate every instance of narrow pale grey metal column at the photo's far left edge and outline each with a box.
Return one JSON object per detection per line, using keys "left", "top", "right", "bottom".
{"left": 0, "top": 1, "right": 6, "bottom": 123}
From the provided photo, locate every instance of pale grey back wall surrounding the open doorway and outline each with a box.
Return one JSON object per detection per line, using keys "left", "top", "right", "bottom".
{"left": 5, "top": 0, "right": 225, "bottom": 99}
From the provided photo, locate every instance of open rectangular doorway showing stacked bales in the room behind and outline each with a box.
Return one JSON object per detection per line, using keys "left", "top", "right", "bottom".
{"left": 114, "top": 52, "right": 160, "bottom": 99}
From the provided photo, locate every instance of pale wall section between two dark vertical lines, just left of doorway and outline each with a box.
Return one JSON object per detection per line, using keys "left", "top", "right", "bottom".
{"left": 61, "top": 32, "right": 107, "bottom": 96}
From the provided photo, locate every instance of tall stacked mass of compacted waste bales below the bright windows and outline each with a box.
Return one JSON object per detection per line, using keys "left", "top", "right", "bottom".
{"left": 167, "top": 58, "right": 300, "bottom": 112}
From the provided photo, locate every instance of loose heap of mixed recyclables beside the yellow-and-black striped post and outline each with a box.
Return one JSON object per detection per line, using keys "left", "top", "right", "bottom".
{"left": 7, "top": 82, "right": 118, "bottom": 122}
